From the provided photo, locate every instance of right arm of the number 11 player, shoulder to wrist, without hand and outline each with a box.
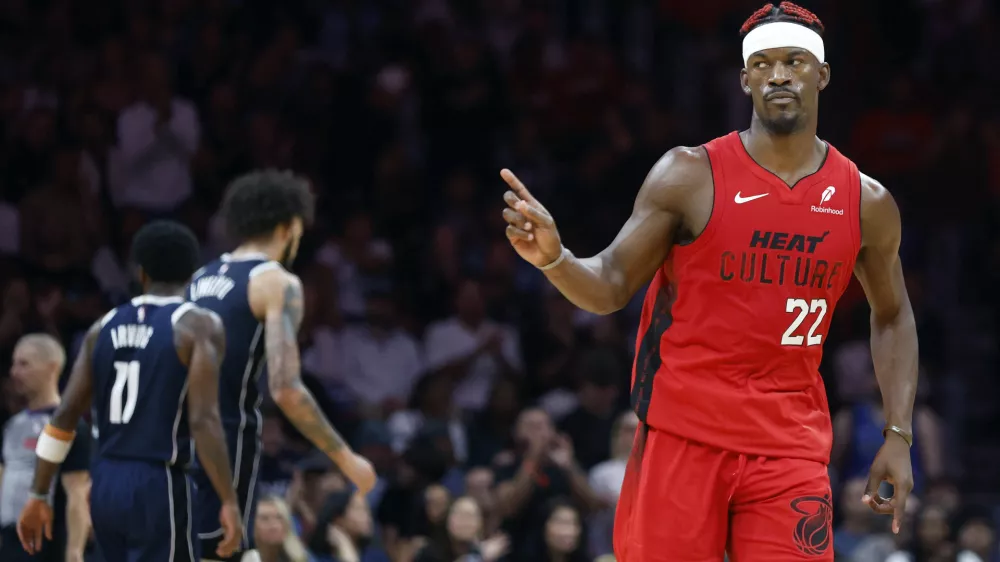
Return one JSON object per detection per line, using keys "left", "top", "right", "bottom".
{"left": 183, "top": 307, "right": 236, "bottom": 503}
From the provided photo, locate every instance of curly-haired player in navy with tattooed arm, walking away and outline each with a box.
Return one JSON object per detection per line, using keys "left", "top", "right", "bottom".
{"left": 187, "top": 170, "right": 375, "bottom": 561}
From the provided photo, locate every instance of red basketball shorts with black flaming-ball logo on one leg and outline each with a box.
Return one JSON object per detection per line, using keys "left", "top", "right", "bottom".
{"left": 614, "top": 425, "right": 833, "bottom": 562}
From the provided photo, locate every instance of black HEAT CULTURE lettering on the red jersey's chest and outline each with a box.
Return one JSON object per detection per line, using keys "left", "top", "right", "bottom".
{"left": 719, "top": 230, "right": 850, "bottom": 289}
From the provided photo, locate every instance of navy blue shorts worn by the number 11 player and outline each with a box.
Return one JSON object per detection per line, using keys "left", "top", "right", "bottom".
{"left": 90, "top": 458, "right": 201, "bottom": 562}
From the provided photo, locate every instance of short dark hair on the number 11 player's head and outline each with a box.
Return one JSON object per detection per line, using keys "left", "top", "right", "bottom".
{"left": 132, "top": 220, "right": 201, "bottom": 284}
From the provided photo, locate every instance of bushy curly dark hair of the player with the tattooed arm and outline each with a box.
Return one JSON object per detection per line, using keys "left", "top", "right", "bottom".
{"left": 222, "top": 169, "right": 314, "bottom": 242}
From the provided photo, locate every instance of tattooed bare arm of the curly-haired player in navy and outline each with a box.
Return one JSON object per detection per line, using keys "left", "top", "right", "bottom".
{"left": 249, "top": 268, "right": 375, "bottom": 492}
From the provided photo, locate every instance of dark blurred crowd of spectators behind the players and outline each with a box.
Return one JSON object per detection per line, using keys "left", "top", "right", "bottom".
{"left": 0, "top": 0, "right": 1000, "bottom": 562}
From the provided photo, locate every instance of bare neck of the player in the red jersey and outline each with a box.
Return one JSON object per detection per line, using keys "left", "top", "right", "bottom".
{"left": 742, "top": 115, "right": 826, "bottom": 173}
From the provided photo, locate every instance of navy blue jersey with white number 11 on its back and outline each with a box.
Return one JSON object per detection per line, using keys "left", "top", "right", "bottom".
{"left": 92, "top": 295, "right": 193, "bottom": 467}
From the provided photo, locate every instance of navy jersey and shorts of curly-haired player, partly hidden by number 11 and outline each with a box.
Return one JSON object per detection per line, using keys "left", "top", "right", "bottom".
{"left": 187, "top": 249, "right": 281, "bottom": 552}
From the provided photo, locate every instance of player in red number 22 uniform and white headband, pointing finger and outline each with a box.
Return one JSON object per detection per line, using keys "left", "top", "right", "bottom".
{"left": 501, "top": 2, "right": 917, "bottom": 562}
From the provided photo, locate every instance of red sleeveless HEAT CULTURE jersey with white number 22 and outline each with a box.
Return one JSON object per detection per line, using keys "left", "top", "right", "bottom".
{"left": 632, "top": 132, "right": 861, "bottom": 463}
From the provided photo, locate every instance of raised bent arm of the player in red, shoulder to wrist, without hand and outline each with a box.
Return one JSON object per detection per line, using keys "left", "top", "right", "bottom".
{"left": 546, "top": 147, "right": 712, "bottom": 314}
